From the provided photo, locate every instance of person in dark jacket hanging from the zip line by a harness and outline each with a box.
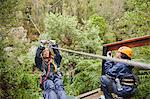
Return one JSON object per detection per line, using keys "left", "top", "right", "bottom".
{"left": 35, "top": 40, "right": 67, "bottom": 99}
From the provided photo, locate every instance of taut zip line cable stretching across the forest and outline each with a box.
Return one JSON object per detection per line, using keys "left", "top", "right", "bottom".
{"left": 29, "top": 15, "right": 150, "bottom": 69}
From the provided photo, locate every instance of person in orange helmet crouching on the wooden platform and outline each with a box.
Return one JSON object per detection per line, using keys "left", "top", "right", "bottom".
{"left": 100, "top": 46, "right": 136, "bottom": 99}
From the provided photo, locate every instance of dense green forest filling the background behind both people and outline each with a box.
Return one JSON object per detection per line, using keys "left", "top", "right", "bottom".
{"left": 0, "top": 0, "right": 150, "bottom": 99}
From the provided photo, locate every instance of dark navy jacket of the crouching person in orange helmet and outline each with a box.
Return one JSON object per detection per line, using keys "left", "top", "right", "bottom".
{"left": 104, "top": 61, "right": 136, "bottom": 97}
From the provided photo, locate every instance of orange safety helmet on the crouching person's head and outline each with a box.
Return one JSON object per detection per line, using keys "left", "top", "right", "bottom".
{"left": 118, "top": 46, "right": 133, "bottom": 58}
